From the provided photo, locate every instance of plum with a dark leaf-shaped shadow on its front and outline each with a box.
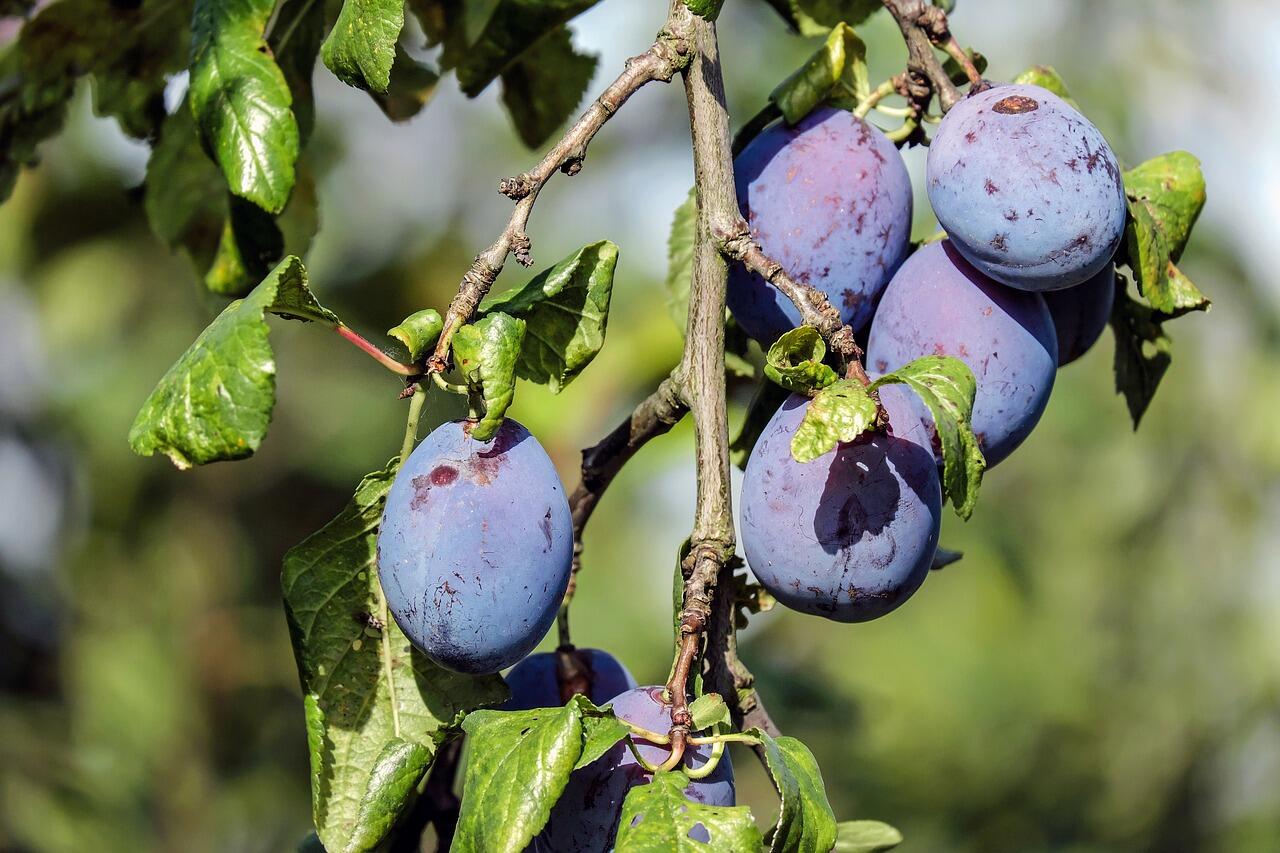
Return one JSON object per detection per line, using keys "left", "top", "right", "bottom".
{"left": 741, "top": 386, "right": 942, "bottom": 622}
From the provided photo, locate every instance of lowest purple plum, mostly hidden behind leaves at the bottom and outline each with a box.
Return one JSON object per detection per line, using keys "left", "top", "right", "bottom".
{"left": 530, "top": 686, "right": 736, "bottom": 853}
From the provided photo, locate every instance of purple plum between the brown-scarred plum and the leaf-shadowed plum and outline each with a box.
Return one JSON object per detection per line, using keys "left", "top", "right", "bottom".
{"left": 867, "top": 240, "right": 1057, "bottom": 466}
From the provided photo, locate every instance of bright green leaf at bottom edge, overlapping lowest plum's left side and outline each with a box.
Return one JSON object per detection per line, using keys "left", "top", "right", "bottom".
{"left": 452, "top": 697, "right": 588, "bottom": 853}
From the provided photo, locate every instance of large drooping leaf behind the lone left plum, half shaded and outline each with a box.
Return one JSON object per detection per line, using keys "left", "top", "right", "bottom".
{"left": 280, "top": 460, "right": 506, "bottom": 850}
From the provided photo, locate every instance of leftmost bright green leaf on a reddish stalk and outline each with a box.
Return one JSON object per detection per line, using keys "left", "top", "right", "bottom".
{"left": 129, "top": 256, "right": 338, "bottom": 469}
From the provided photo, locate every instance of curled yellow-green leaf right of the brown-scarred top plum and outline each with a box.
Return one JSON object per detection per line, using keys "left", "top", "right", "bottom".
{"left": 1124, "top": 151, "right": 1210, "bottom": 316}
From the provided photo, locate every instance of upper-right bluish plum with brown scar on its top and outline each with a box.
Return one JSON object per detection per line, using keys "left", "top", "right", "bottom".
{"left": 927, "top": 85, "right": 1126, "bottom": 291}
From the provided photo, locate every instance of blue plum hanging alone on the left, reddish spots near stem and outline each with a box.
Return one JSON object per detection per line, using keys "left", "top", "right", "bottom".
{"left": 378, "top": 418, "right": 573, "bottom": 675}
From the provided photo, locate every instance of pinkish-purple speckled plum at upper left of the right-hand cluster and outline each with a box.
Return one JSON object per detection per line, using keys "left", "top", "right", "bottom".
{"left": 728, "top": 108, "right": 911, "bottom": 347}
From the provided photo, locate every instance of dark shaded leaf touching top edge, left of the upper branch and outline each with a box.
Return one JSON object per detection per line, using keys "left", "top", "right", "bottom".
{"left": 456, "top": 0, "right": 598, "bottom": 97}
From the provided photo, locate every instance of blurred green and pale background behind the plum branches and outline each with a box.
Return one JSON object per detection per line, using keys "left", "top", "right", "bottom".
{"left": 0, "top": 0, "right": 1280, "bottom": 853}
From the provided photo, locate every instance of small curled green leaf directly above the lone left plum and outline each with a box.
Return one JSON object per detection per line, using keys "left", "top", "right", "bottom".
{"left": 453, "top": 311, "right": 525, "bottom": 442}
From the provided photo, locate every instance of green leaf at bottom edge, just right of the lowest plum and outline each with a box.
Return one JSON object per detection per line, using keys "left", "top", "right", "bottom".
{"left": 749, "top": 729, "right": 836, "bottom": 853}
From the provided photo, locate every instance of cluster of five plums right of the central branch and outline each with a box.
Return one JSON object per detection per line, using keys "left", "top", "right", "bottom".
{"left": 728, "top": 85, "right": 1126, "bottom": 621}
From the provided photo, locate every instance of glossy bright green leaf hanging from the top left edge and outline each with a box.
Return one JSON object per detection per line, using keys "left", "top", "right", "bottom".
{"left": 189, "top": 0, "right": 298, "bottom": 213}
